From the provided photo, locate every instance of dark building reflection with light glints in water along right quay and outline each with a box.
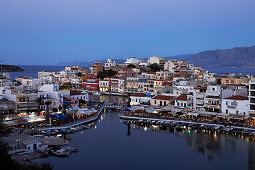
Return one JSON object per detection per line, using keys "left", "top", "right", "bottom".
{"left": 127, "top": 121, "right": 255, "bottom": 170}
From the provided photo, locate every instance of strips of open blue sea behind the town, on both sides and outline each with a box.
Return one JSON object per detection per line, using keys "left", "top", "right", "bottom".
{"left": 7, "top": 65, "right": 255, "bottom": 80}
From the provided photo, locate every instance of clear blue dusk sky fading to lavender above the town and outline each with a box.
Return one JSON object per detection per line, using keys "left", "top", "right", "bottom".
{"left": 0, "top": 0, "right": 255, "bottom": 65}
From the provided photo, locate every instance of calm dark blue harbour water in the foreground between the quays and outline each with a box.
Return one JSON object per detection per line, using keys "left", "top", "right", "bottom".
{"left": 36, "top": 111, "right": 255, "bottom": 170}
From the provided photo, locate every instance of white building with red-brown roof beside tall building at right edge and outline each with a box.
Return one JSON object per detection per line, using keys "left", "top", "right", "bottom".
{"left": 221, "top": 96, "right": 249, "bottom": 115}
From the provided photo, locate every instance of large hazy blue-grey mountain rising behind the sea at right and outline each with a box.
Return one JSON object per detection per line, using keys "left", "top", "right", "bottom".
{"left": 189, "top": 46, "right": 255, "bottom": 68}
